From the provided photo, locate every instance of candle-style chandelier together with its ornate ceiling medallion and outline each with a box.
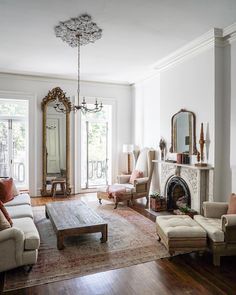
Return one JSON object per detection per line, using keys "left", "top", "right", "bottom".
{"left": 54, "top": 14, "right": 103, "bottom": 114}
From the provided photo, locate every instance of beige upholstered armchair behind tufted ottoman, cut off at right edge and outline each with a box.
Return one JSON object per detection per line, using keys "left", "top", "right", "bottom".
{"left": 194, "top": 202, "right": 236, "bottom": 266}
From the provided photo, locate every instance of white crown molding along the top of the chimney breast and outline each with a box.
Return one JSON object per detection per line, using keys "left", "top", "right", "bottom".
{"left": 153, "top": 28, "right": 223, "bottom": 71}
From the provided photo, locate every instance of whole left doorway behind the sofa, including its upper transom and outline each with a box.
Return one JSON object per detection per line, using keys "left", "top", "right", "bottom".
{"left": 0, "top": 99, "right": 29, "bottom": 189}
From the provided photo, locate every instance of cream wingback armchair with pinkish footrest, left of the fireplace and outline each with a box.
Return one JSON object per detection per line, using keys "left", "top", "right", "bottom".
{"left": 97, "top": 148, "right": 155, "bottom": 208}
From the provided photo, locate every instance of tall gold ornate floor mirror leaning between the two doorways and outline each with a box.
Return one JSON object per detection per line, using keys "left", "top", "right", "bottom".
{"left": 41, "top": 87, "right": 71, "bottom": 196}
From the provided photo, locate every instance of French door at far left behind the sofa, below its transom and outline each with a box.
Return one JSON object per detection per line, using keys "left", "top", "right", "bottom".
{"left": 0, "top": 117, "right": 28, "bottom": 188}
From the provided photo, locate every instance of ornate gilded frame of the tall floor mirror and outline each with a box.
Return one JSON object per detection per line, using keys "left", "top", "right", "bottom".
{"left": 41, "top": 87, "right": 71, "bottom": 196}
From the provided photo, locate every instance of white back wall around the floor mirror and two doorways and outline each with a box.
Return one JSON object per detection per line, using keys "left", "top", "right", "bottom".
{"left": 0, "top": 74, "right": 131, "bottom": 195}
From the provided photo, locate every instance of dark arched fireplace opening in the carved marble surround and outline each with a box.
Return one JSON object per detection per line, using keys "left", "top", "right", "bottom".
{"left": 166, "top": 176, "right": 191, "bottom": 210}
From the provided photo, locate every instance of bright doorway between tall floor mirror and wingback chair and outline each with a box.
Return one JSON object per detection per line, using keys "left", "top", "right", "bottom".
{"left": 81, "top": 105, "right": 112, "bottom": 189}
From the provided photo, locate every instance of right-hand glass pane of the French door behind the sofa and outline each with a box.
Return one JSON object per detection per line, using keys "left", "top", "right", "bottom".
{"left": 12, "top": 120, "right": 28, "bottom": 186}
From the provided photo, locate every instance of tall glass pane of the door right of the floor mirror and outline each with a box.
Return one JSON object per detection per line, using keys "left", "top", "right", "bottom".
{"left": 86, "top": 122, "right": 108, "bottom": 188}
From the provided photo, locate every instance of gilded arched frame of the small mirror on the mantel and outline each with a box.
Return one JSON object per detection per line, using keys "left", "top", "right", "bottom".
{"left": 170, "top": 109, "right": 197, "bottom": 155}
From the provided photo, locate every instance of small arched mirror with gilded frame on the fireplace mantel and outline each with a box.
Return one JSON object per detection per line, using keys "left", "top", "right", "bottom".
{"left": 170, "top": 109, "right": 197, "bottom": 155}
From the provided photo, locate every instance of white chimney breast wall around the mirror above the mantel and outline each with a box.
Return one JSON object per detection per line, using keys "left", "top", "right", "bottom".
{"left": 160, "top": 48, "right": 215, "bottom": 164}
